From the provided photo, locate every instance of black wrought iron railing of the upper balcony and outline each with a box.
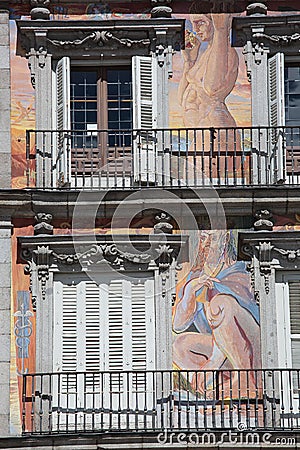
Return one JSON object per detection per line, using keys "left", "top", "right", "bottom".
{"left": 26, "top": 127, "right": 300, "bottom": 190}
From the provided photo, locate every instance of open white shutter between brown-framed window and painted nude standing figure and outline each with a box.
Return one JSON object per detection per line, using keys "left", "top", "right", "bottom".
{"left": 132, "top": 56, "right": 157, "bottom": 183}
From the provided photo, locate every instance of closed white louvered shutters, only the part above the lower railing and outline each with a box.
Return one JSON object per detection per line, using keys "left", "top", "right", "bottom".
{"left": 54, "top": 276, "right": 155, "bottom": 372}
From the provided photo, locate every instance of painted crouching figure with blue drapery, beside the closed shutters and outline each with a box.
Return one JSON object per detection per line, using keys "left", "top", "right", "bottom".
{"left": 173, "top": 231, "right": 260, "bottom": 393}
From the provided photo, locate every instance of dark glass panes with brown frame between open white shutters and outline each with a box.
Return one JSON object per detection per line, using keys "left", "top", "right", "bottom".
{"left": 71, "top": 67, "right": 132, "bottom": 147}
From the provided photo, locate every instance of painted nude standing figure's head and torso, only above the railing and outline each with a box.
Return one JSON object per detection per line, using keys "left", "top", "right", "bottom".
{"left": 178, "top": 14, "right": 239, "bottom": 127}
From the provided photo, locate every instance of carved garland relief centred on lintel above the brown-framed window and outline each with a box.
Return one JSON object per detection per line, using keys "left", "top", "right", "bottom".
{"left": 47, "top": 30, "right": 150, "bottom": 48}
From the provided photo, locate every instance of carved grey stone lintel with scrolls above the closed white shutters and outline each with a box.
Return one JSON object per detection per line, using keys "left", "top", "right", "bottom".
{"left": 18, "top": 234, "right": 188, "bottom": 309}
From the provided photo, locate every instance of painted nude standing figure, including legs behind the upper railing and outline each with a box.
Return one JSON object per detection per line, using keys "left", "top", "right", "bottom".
{"left": 178, "top": 14, "right": 241, "bottom": 179}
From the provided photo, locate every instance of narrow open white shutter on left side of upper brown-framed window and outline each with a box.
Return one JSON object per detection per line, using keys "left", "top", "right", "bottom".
{"left": 56, "top": 56, "right": 71, "bottom": 186}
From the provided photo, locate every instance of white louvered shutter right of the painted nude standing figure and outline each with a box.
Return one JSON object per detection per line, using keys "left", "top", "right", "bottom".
{"left": 268, "top": 53, "right": 285, "bottom": 183}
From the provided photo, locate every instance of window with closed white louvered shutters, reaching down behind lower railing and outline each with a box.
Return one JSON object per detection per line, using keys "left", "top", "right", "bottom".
{"left": 53, "top": 273, "right": 155, "bottom": 426}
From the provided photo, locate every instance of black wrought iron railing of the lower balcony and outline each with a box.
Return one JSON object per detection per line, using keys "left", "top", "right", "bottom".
{"left": 22, "top": 369, "right": 300, "bottom": 434}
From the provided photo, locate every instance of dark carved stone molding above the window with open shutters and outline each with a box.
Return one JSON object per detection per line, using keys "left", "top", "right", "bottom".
{"left": 17, "top": 18, "right": 184, "bottom": 59}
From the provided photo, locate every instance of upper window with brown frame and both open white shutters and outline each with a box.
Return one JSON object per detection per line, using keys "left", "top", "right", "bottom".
{"left": 56, "top": 56, "right": 157, "bottom": 186}
